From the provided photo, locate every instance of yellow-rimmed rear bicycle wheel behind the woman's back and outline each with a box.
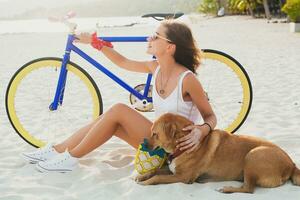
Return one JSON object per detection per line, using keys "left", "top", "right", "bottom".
{"left": 197, "top": 49, "right": 253, "bottom": 133}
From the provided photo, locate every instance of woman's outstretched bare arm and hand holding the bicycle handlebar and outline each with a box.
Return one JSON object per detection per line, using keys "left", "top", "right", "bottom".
{"left": 75, "top": 33, "right": 158, "bottom": 73}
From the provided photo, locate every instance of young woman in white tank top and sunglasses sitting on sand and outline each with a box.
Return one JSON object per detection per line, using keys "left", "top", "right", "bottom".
{"left": 22, "top": 20, "right": 217, "bottom": 172}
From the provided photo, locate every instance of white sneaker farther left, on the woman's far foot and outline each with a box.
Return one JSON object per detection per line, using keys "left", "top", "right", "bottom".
{"left": 21, "top": 144, "right": 59, "bottom": 163}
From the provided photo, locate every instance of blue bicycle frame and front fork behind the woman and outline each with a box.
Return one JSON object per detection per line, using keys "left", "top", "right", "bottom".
{"left": 49, "top": 34, "right": 152, "bottom": 110}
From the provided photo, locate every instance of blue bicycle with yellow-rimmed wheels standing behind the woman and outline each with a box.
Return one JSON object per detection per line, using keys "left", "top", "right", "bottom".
{"left": 6, "top": 13, "right": 252, "bottom": 147}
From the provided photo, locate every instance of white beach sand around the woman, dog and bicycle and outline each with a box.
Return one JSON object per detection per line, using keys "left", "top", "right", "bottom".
{"left": 0, "top": 17, "right": 300, "bottom": 200}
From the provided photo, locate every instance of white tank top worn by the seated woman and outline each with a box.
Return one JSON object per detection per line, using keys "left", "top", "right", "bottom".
{"left": 152, "top": 66, "right": 203, "bottom": 124}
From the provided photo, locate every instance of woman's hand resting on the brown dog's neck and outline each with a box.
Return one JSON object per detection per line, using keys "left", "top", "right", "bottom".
{"left": 176, "top": 125, "right": 209, "bottom": 153}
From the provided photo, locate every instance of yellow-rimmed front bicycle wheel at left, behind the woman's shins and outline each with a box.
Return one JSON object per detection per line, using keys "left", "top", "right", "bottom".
{"left": 6, "top": 58, "right": 102, "bottom": 147}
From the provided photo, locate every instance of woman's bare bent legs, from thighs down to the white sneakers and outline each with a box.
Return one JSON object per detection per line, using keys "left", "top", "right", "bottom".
{"left": 56, "top": 104, "right": 152, "bottom": 157}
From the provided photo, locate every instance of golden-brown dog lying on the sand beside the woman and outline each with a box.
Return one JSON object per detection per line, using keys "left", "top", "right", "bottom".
{"left": 136, "top": 113, "right": 300, "bottom": 193}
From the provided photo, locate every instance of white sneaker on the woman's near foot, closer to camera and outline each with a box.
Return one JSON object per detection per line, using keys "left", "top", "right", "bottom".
{"left": 36, "top": 151, "right": 78, "bottom": 172}
